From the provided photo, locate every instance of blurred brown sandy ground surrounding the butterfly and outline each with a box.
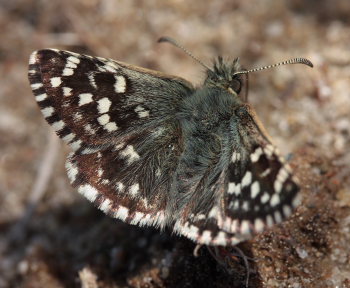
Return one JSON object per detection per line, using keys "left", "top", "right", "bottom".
{"left": 0, "top": 0, "right": 350, "bottom": 288}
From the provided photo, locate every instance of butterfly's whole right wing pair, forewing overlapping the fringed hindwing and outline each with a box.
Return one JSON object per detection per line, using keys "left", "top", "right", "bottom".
{"left": 174, "top": 106, "right": 299, "bottom": 246}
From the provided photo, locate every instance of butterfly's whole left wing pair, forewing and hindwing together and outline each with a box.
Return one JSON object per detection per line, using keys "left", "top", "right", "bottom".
{"left": 29, "top": 49, "right": 193, "bottom": 226}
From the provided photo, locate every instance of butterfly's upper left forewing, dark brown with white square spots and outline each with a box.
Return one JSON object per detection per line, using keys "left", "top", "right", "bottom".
{"left": 29, "top": 49, "right": 193, "bottom": 153}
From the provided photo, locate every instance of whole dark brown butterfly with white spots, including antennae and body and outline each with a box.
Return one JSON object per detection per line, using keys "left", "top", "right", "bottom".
{"left": 29, "top": 37, "right": 312, "bottom": 246}
